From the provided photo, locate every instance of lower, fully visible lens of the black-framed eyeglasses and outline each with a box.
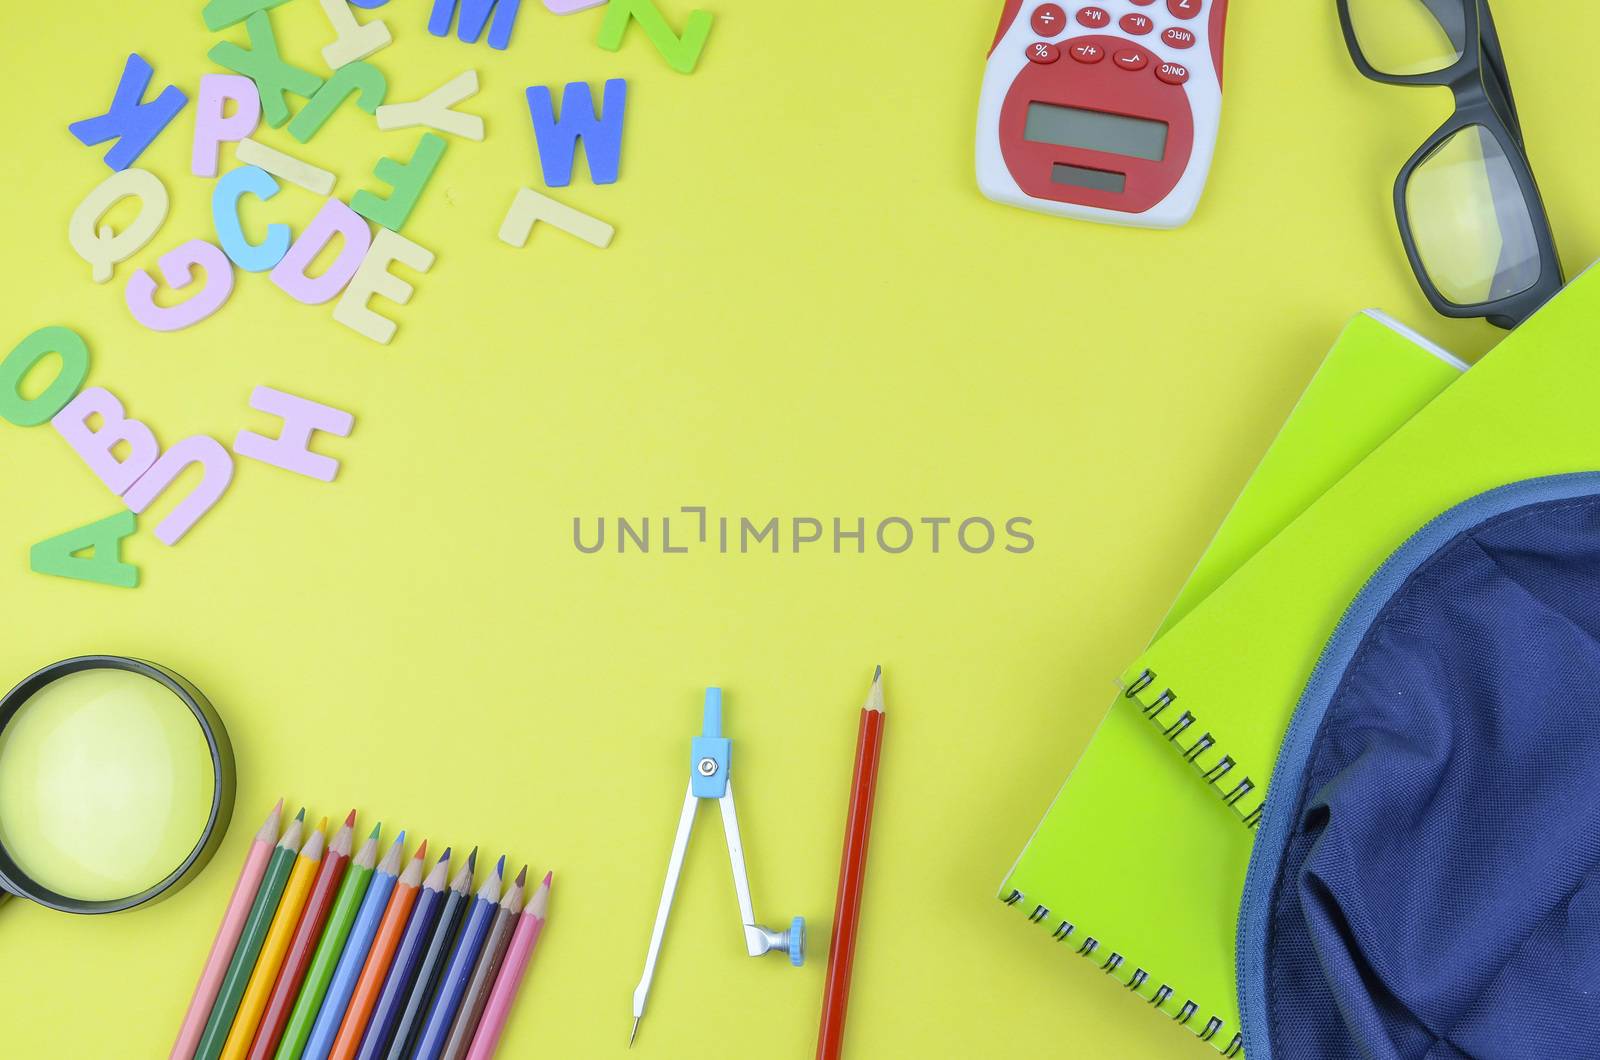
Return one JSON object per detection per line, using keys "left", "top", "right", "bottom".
{"left": 1405, "top": 125, "right": 1539, "bottom": 306}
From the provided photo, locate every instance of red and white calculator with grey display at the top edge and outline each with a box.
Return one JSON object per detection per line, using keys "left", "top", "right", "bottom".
{"left": 978, "top": 0, "right": 1227, "bottom": 227}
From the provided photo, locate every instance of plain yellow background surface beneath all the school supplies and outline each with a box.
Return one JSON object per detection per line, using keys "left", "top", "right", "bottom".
{"left": 0, "top": 0, "right": 1600, "bottom": 1058}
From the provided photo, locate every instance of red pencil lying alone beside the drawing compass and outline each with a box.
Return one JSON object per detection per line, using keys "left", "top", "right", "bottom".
{"left": 816, "top": 666, "right": 883, "bottom": 1060}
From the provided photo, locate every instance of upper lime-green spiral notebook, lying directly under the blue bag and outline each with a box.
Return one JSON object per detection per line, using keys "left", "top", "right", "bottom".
{"left": 1122, "top": 269, "right": 1600, "bottom": 825}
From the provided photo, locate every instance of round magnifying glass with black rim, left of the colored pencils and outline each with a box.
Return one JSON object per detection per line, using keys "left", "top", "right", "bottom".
{"left": 0, "top": 655, "right": 234, "bottom": 913}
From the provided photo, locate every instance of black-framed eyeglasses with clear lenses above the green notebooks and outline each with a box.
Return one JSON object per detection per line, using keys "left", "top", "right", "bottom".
{"left": 1338, "top": 0, "right": 1565, "bottom": 328}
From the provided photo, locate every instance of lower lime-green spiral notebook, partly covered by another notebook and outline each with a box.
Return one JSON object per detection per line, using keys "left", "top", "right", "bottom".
{"left": 1000, "top": 312, "right": 1466, "bottom": 1055}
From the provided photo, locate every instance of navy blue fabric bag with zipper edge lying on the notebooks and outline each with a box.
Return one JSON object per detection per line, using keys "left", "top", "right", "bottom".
{"left": 1238, "top": 474, "right": 1600, "bottom": 1060}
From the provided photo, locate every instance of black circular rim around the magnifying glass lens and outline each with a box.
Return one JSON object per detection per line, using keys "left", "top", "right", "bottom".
{"left": 0, "top": 655, "right": 234, "bottom": 914}
